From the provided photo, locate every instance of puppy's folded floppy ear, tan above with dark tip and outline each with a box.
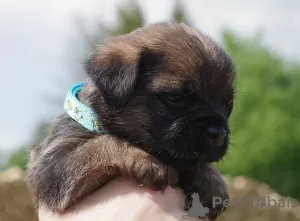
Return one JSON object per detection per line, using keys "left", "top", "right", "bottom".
{"left": 86, "top": 43, "right": 162, "bottom": 108}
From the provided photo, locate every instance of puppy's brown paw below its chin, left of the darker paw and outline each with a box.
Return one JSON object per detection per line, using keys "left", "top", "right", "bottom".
{"left": 127, "top": 155, "right": 178, "bottom": 191}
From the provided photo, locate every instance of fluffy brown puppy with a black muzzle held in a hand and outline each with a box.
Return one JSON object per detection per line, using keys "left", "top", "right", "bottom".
{"left": 28, "top": 22, "right": 235, "bottom": 219}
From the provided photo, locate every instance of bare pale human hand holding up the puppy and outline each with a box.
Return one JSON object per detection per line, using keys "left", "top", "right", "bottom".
{"left": 39, "top": 178, "right": 208, "bottom": 221}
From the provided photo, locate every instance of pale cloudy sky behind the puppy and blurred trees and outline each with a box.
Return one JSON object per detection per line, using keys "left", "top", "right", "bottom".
{"left": 0, "top": 0, "right": 300, "bottom": 152}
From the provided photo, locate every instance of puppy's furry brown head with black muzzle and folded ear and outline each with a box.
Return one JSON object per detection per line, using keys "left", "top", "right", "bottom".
{"left": 86, "top": 22, "right": 235, "bottom": 162}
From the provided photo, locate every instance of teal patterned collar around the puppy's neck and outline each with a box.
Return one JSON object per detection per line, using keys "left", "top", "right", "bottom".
{"left": 64, "top": 82, "right": 104, "bottom": 133}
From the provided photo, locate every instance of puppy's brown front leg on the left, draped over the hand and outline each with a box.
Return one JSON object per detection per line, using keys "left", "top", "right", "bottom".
{"left": 28, "top": 135, "right": 177, "bottom": 211}
